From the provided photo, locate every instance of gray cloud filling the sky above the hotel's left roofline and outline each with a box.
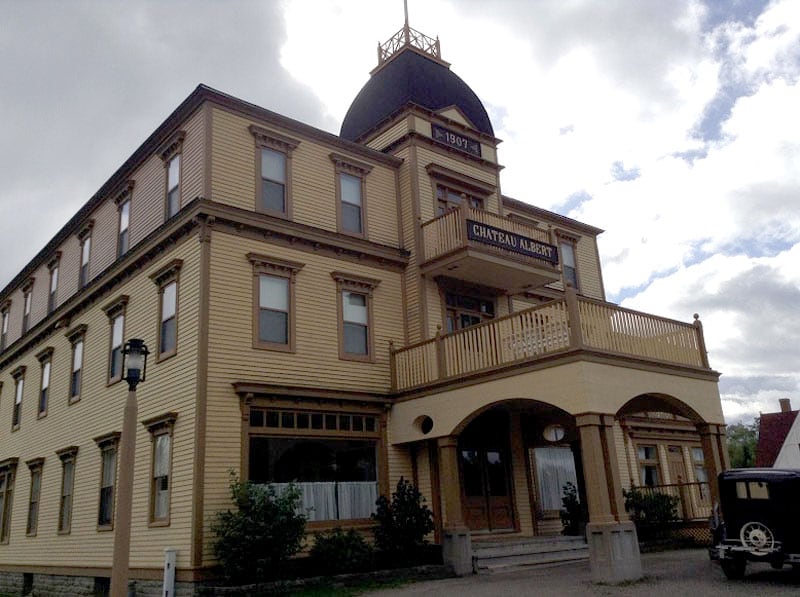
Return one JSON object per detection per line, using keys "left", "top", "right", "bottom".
{"left": 0, "top": 0, "right": 336, "bottom": 287}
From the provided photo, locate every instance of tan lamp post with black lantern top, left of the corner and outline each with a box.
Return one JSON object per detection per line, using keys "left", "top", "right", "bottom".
{"left": 111, "top": 338, "right": 148, "bottom": 597}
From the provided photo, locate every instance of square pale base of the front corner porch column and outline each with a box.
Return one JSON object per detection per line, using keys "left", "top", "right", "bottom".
{"left": 586, "top": 522, "right": 642, "bottom": 583}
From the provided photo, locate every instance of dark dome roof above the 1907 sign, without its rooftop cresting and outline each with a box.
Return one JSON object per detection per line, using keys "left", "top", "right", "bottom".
{"left": 339, "top": 49, "right": 494, "bottom": 141}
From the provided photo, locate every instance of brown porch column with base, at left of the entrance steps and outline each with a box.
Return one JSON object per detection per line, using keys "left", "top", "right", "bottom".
{"left": 437, "top": 436, "right": 472, "bottom": 576}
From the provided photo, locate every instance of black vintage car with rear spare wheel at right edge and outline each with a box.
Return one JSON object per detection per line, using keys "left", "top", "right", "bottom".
{"left": 711, "top": 468, "right": 800, "bottom": 579}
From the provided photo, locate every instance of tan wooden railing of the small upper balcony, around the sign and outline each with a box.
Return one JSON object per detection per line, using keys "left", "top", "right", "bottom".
{"left": 422, "top": 204, "right": 558, "bottom": 267}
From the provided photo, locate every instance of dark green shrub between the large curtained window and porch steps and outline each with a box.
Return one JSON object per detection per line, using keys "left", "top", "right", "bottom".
{"left": 372, "top": 477, "right": 434, "bottom": 562}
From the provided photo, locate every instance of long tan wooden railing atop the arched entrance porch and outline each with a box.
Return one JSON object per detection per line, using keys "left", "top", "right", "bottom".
{"left": 391, "top": 287, "right": 709, "bottom": 391}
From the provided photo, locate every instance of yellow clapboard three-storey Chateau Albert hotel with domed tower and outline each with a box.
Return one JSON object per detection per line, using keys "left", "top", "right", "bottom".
{"left": 0, "top": 26, "right": 726, "bottom": 594}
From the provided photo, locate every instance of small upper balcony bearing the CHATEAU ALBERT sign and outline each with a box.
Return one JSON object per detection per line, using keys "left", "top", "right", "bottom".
{"left": 420, "top": 204, "right": 561, "bottom": 294}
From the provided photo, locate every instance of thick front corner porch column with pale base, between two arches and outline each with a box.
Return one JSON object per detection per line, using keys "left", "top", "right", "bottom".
{"left": 575, "top": 413, "right": 642, "bottom": 583}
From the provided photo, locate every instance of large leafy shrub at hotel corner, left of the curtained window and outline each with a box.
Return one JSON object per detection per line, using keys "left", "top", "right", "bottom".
{"left": 211, "top": 473, "right": 306, "bottom": 583}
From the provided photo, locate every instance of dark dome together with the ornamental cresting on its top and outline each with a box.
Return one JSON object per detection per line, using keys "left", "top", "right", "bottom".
{"left": 340, "top": 21, "right": 494, "bottom": 141}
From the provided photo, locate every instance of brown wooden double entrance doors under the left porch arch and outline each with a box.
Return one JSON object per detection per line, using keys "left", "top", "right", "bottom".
{"left": 458, "top": 412, "right": 514, "bottom": 531}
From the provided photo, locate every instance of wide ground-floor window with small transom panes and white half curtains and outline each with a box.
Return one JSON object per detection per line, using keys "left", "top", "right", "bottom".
{"left": 248, "top": 408, "right": 380, "bottom": 522}
